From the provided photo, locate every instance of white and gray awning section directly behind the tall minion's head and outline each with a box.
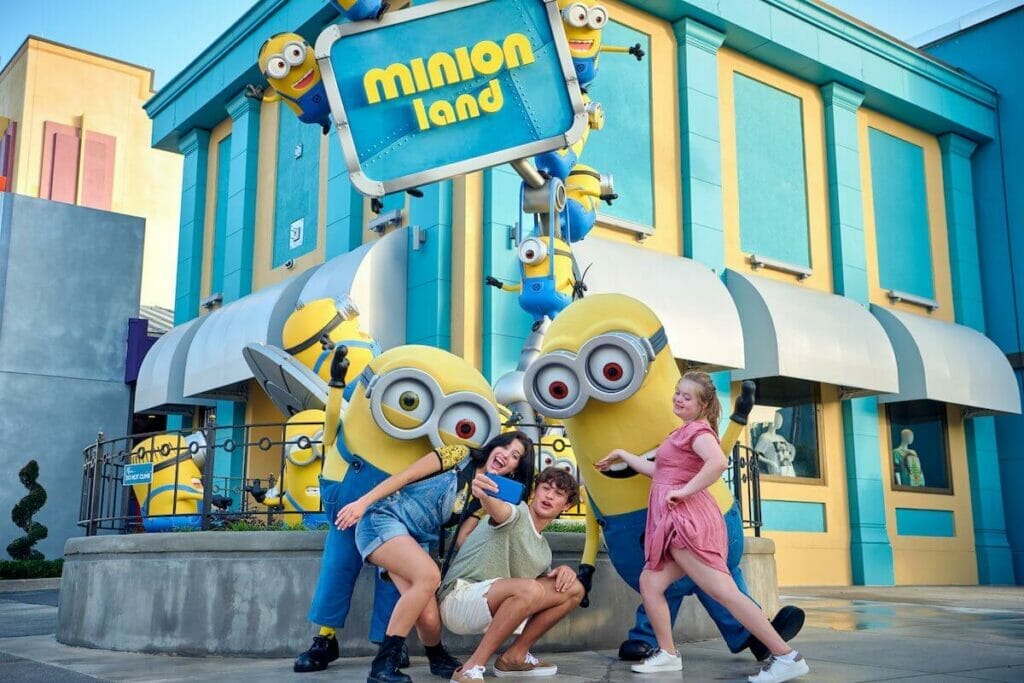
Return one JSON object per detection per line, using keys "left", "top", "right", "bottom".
{"left": 572, "top": 236, "right": 743, "bottom": 370}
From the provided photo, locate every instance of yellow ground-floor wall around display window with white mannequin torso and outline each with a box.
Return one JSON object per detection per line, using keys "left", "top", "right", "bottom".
{"left": 749, "top": 383, "right": 853, "bottom": 586}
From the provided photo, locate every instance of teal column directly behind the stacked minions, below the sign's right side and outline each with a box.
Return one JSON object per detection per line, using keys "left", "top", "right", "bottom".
{"left": 481, "top": 166, "right": 534, "bottom": 382}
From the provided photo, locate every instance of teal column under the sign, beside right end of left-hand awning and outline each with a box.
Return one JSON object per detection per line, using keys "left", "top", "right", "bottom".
{"left": 406, "top": 180, "right": 452, "bottom": 350}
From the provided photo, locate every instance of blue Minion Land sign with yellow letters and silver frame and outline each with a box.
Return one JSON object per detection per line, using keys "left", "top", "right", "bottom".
{"left": 316, "top": 0, "right": 587, "bottom": 197}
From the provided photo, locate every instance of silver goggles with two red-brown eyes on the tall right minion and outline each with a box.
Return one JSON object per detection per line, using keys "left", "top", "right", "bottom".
{"left": 523, "top": 328, "right": 668, "bottom": 419}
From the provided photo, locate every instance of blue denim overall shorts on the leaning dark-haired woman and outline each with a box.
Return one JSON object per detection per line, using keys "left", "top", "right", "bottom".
{"left": 355, "top": 468, "right": 459, "bottom": 561}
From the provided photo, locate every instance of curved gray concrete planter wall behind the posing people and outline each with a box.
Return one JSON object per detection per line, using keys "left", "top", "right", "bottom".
{"left": 56, "top": 531, "right": 778, "bottom": 656}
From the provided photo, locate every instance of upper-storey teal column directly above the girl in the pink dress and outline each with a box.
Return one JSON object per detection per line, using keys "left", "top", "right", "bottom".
{"left": 673, "top": 17, "right": 725, "bottom": 272}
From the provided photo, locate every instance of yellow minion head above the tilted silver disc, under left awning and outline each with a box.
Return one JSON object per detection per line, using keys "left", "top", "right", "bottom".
{"left": 281, "top": 296, "right": 381, "bottom": 382}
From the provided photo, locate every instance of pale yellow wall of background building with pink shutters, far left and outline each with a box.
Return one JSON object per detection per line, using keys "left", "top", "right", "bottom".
{"left": 0, "top": 37, "right": 182, "bottom": 308}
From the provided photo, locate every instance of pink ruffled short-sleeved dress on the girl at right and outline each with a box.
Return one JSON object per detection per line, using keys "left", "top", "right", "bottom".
{"left": 644, "top": 420, "right": 729, "bottom": 573}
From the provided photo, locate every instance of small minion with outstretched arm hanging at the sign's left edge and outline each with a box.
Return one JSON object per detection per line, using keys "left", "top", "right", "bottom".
{"left": 254, "top": 33, "right": 331, "bottom": 135}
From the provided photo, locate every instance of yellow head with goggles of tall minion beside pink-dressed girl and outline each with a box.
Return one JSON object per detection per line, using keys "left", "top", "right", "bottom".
{"left": 524, "top": 294, "right": 679, "bottom": 514}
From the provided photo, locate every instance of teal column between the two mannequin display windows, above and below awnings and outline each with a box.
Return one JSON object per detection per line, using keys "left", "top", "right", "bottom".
{"left": 821, "top": 83, "right": 894, "bottom": 586}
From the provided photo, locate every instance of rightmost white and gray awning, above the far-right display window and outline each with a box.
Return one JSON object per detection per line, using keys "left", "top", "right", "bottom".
{"left": 871, "top": 304, "right": 1021, "bottom": 415}
